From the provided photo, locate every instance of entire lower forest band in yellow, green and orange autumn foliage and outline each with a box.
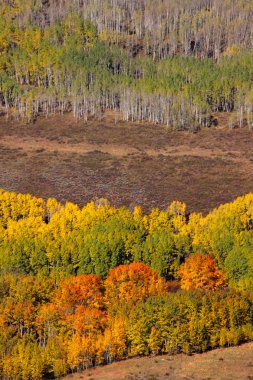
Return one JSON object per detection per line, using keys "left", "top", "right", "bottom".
{"left": 0, "top": 190, "right": 253, "bottom": 380}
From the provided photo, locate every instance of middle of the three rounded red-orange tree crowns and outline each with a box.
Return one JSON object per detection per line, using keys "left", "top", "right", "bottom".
{"left": 105, "top": 263, "right": 167, "bottom": 304}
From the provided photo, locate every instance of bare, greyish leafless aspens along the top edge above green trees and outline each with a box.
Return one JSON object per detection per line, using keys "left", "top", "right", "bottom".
{"left": 1, "top": 0, "right": 253, "bottom": 59}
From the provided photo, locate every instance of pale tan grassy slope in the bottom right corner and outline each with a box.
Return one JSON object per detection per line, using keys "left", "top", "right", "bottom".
{"left": 64, "top": 343, "right": 253, "bottom": 380}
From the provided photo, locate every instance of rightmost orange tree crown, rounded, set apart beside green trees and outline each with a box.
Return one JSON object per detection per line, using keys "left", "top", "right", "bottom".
{"left": 178, "top": 253, "right": 226, "bottom": 290}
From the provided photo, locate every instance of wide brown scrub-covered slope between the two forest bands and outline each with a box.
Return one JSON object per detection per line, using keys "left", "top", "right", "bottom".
{"left": 0, "top": 115, "right": 253, "bottom": 212}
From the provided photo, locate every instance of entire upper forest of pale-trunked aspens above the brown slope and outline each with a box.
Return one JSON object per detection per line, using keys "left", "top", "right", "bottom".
{"left": 0, "top": 0, "right": 253, "bottom": 130}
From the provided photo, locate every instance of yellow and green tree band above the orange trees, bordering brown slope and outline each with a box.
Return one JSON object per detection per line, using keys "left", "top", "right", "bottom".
{"left": 0, "top": 190, "right": 253, "bottom": 290}
